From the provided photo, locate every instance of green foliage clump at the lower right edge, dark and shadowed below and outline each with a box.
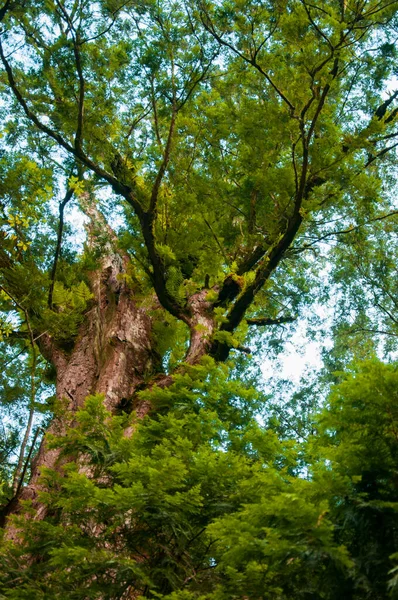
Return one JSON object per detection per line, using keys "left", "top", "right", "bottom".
{"left": 310, "top": 359, "right": 398, "bottom": 600}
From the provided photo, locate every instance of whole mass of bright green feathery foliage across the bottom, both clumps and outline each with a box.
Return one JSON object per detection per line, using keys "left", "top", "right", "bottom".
{"left": 1, "top": 360, "right": 398, "bottom": 600}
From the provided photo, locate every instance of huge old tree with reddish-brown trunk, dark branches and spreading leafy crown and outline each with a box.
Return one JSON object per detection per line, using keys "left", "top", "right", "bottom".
{"left": 0, "top": 0, "right": 398, "bottom": 597}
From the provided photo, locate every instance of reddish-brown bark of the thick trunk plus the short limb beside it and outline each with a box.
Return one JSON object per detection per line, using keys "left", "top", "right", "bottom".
{"left": 0, "top": 194, "right": 215, "bottom": 537}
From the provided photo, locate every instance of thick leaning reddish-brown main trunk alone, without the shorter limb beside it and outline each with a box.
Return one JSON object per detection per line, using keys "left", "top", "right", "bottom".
{"left": 3, "top": 243, "right": 161, "bottom": 524}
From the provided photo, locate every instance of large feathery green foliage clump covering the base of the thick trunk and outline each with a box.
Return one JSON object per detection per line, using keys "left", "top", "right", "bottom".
{"left": 1, "top": 364, "right": 351, "bottom": 600}
